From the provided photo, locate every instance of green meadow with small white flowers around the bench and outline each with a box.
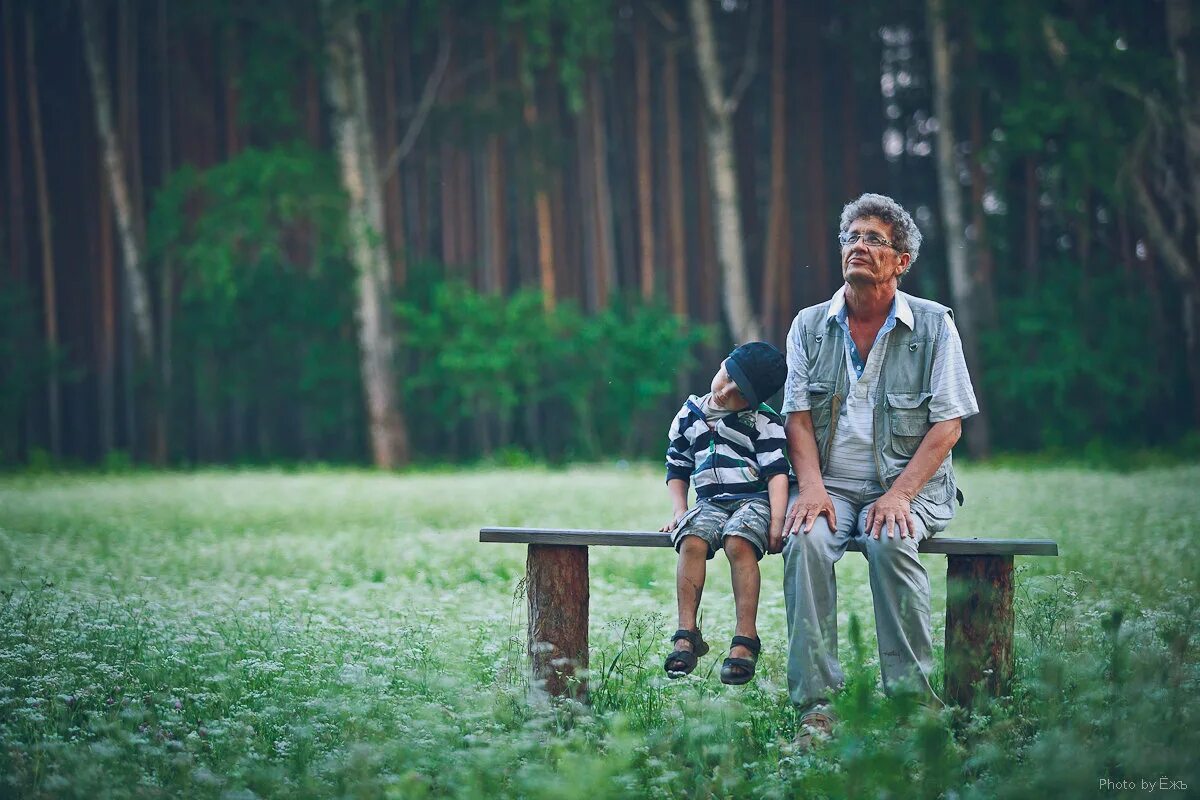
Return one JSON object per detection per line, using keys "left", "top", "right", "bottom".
{"left": 0, "top": 465, "right": 1200, "bottom": 798}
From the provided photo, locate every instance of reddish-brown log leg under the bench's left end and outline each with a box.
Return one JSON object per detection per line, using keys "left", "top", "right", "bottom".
{"left": 526, "top": 545, "right": 588, "bottom": 700}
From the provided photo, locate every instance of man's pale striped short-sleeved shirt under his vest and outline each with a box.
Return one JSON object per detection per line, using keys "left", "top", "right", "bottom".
{"left": 784, "top": 285, "right": 979, "bottom": 480}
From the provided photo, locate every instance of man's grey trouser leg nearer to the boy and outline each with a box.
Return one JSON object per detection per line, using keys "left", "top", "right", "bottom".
{"left": 784, "top": 489, "right": 858, "bottom": 712}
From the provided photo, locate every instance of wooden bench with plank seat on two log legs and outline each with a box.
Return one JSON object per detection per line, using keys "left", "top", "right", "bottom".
{"left": 479, "top": 528, "right": 1058, "bottom": 706}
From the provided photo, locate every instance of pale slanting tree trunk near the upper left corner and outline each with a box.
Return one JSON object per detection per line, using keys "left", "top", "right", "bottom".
{"left": 82, "top": 0, "right": 155, "bottom": 369}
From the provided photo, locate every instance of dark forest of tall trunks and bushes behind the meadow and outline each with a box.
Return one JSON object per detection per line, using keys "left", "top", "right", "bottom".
{"left": 0, "top": 0, "right": 1200, "bottom": 468}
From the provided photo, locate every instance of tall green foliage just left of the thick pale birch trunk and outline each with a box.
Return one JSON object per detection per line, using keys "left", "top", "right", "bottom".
{"left": 149, "top": 145, "right": 361, "bottom": 458}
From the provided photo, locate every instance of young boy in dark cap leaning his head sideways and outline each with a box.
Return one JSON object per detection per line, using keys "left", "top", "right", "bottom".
{"left": 661, "top": 342, "right": 788, "bottom": 684}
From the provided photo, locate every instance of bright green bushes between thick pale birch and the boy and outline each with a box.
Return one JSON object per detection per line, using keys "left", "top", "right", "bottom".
{"left": 396, "top": 282, "right": 707, "bottom": 457}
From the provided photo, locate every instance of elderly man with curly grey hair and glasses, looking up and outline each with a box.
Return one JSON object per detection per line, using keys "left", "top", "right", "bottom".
{"left": 784, "top": 194, "right": 979, "bottom": 748}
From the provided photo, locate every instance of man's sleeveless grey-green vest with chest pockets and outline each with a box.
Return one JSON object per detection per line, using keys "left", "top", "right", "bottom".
{"left": 797, "top": 294, "right": 958, "bottom": 522}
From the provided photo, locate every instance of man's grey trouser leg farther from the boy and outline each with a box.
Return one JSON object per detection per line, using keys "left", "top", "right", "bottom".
{"left": 858, "top": 506, "right": 941, "bottom": 705}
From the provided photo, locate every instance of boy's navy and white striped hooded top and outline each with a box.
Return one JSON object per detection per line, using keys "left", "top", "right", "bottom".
{"left": 667, "top": 395, "right": 788, "bottom": 500}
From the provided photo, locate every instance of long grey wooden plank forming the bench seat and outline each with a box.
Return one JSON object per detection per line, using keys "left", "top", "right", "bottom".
{"left": 479, "top": 528, "right": 1058, "bottom": 555}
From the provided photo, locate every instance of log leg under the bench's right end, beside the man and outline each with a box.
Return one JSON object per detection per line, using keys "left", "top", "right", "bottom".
{"left": 946, "top": 555, "right": 1013, "bottom": 708}
